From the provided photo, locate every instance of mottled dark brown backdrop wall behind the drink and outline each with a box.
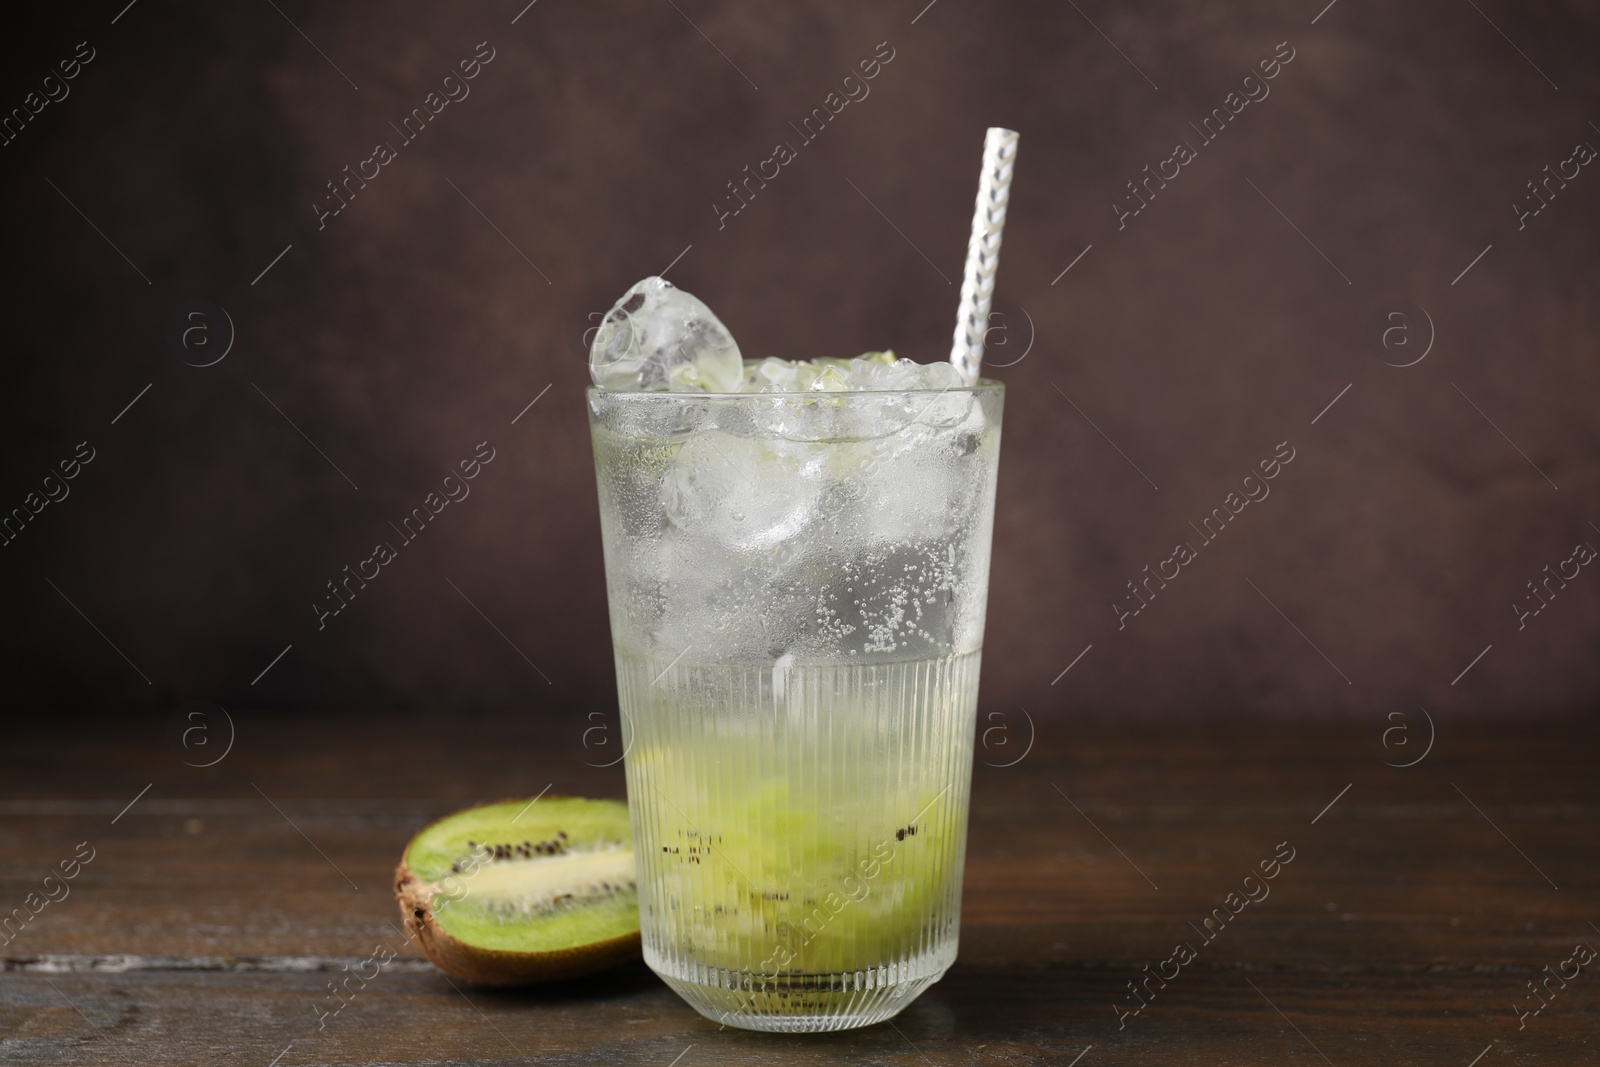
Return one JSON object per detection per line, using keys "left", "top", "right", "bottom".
{"left": 0, "top": 0, "right": 1600, "bottom": 723}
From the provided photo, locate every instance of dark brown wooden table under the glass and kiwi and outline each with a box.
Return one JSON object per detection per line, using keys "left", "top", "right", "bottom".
{"left": 0, "top": 712, "right": 1600, "bottom": 1067}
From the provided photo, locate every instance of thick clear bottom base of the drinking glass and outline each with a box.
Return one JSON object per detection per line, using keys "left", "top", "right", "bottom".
{"left": 646, "top": 960, "right": 949, "bottom": 1033}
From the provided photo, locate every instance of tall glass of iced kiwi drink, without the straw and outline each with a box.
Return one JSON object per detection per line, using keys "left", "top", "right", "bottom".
{"left": 589, "top": 280, "right": 1003, "bottom": 1030}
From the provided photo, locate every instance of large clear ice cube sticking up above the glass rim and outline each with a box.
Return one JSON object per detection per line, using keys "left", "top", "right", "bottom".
{"left": 589, "top": 277, "right": 744, "bottom": 392}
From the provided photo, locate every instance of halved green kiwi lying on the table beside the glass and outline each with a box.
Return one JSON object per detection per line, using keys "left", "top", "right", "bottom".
{"left": 395, "top": 797, "right": 640, "bottom": 985}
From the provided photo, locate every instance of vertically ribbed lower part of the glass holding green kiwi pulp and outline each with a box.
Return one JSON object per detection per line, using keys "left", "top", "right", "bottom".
{"left": 618, "top": 653, "right": 979, "bottom": 1030}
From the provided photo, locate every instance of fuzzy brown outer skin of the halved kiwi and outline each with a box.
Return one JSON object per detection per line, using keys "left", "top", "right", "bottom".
{"left": 395, "top": 799, "right": 642, "bottom": 985}
